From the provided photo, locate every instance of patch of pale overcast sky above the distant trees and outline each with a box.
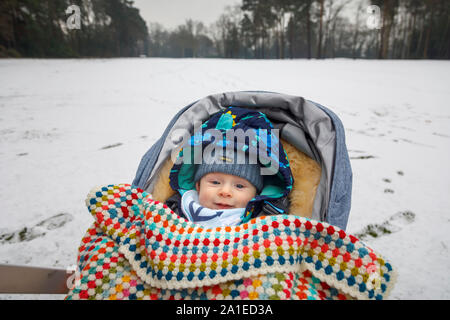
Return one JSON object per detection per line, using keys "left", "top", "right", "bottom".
{"left": 134, "top": 0, "right": 242, "bottom": 29}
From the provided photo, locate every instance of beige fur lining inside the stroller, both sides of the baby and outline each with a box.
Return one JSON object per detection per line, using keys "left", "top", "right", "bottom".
{"left": 151, "top": 139, "right": 321, "bottom": 218}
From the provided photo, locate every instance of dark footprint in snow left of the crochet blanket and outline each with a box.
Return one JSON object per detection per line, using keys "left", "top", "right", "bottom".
{"left": 0, "top": 213, "right": 73, "bottom": 244}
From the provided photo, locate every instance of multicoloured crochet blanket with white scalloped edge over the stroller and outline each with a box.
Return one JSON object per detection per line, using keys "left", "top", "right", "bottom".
{"left": 66, "top": 184, "right": 395, "bottom": 300}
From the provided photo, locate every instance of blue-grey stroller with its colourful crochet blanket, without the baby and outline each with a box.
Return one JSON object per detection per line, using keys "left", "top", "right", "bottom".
{"left": 0, "top": 91, "right": 395, "bottom": 300}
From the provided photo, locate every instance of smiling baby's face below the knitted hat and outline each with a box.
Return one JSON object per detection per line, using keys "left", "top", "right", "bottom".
{"left": 196, "top": 172, "right": 256, "bottom": 209}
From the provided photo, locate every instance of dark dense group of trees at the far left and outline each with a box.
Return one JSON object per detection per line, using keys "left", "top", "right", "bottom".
{"left": 0, "top": 0, "right": 149, "bottom": 58}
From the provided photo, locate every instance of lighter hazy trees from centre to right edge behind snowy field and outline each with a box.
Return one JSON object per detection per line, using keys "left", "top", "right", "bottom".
{"left": 154, "top": 0, "right": 450, "bottom": 59}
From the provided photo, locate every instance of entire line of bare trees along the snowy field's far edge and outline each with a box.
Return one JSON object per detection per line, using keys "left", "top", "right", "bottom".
{"left": 0, "top": 0, "right": 450, "bottom": 59}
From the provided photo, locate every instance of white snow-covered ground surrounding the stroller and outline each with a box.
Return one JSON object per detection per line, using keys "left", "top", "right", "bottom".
{"left": 0, "top": 59, "right": 450, "bottom": 299}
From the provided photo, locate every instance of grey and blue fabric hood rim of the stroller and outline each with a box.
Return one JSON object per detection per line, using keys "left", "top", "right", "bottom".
{"left": 132, "top": 91, "right": 352, "bottom": 230}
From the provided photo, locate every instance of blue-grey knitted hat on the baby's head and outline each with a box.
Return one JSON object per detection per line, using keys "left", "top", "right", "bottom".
{"left": 194, "top": 148, "right": 264, "bottom": 193}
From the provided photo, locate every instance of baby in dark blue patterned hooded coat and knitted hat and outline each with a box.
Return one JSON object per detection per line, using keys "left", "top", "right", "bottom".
{"left": 166, "top": 107, "right": 293, "bottom": 227}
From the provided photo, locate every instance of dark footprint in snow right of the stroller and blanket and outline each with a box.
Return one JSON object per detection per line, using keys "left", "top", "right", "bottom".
{"left": 355, "top": 211, "right": 416, "bottom": 240}
